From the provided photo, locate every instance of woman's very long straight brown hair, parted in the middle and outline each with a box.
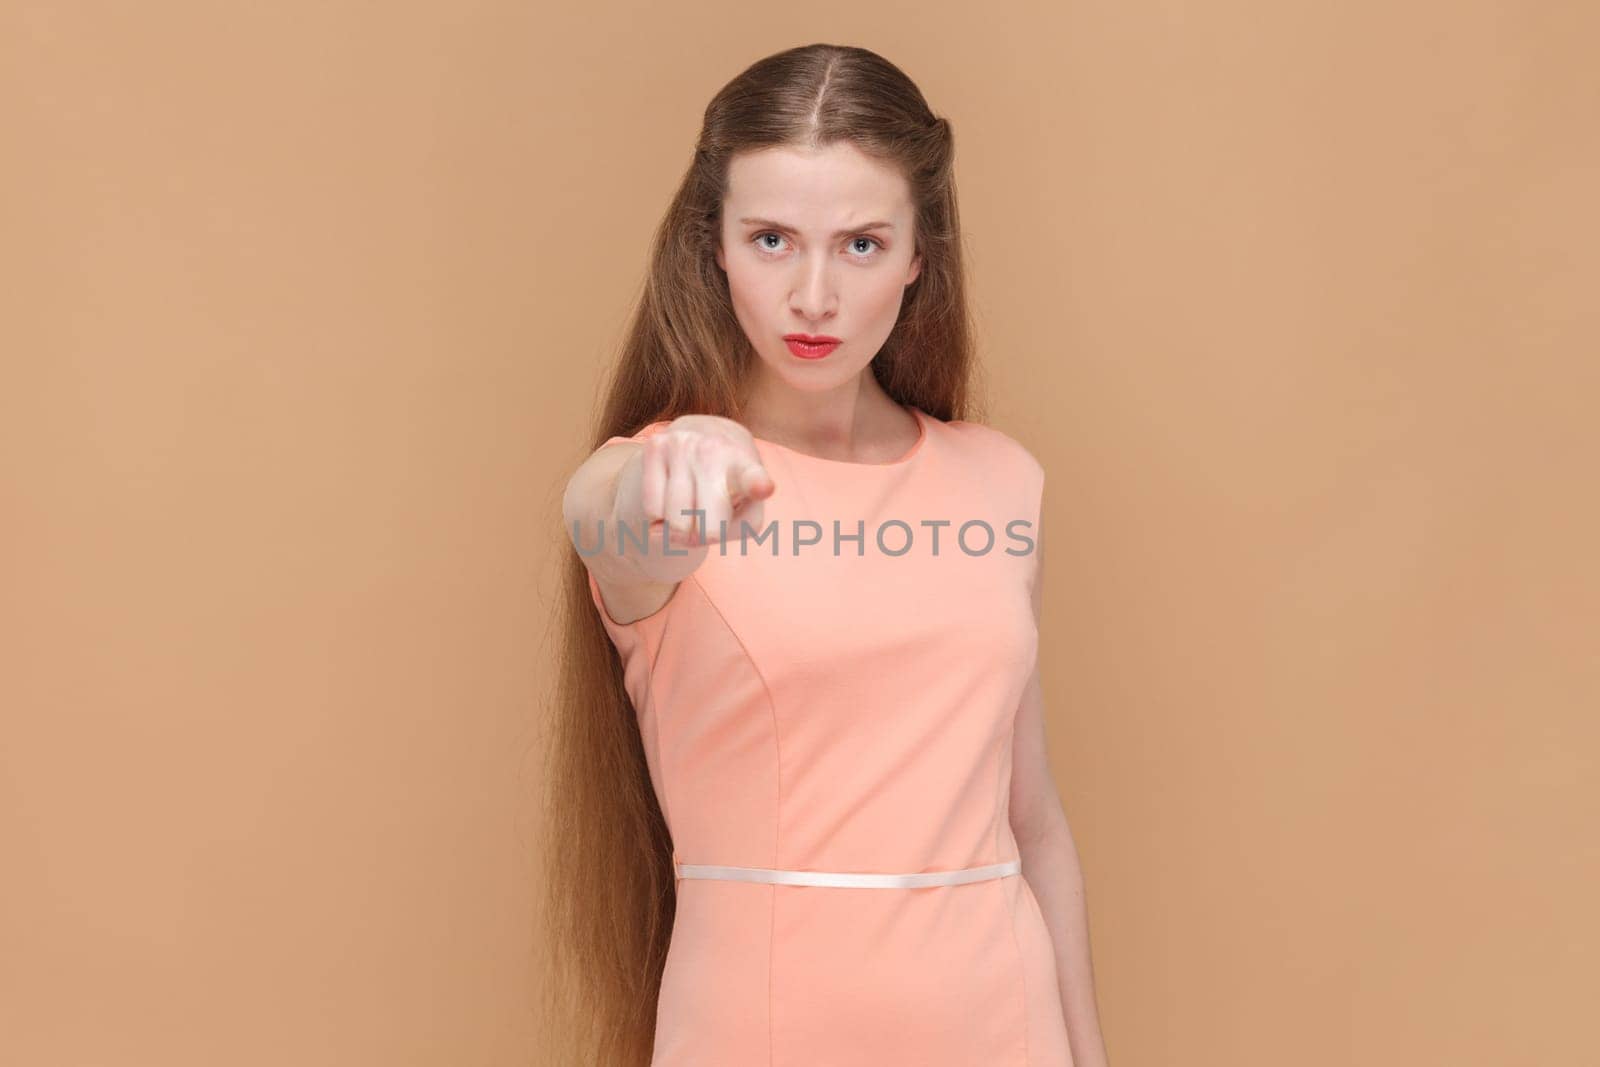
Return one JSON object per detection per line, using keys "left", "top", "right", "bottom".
{"left": 539, "top": 45, "right": 973, "bottom": 1067}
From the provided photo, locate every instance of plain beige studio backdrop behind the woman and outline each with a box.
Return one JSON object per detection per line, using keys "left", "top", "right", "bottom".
{"left": 0, "top": 0, "right": 1600, "bottom": 1067}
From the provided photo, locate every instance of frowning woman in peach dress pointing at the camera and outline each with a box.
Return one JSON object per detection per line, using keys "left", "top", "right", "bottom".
{"left": 546, "top": 45, "right": 1106, "bottom": 1067}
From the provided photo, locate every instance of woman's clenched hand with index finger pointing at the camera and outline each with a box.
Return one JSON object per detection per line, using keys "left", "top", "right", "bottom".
{"left": 608, "top": 414, "right": 776, "bottom": 582}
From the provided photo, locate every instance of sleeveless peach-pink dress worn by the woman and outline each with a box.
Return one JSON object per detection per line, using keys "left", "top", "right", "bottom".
{"left": 587, "top": 408, "right": 1072, "bottom": 1067}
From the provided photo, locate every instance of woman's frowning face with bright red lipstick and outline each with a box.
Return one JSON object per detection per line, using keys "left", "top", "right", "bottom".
{"left": 717, "top": 142, "right": 922, "bottom": 392}
